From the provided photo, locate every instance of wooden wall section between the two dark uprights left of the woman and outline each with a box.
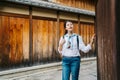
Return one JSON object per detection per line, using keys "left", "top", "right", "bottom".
{"left": 33, "top": 19, "right": 59, "bottom": 62}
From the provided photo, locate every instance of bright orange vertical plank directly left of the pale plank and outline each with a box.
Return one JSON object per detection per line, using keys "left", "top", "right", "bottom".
{"left": 15, "top": 18, "right": 23, "bottom": 63}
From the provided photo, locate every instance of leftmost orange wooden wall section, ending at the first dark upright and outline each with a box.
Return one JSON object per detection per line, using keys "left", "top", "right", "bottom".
{"left": 0, "top": 16, "right": 29, "bottom": 66}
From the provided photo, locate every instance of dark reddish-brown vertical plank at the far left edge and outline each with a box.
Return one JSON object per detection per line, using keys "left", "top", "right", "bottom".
{"left": 0, "top": 16, "right": 10, "bottom": 67}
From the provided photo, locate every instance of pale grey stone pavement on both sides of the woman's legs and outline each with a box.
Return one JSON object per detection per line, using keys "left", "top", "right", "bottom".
{"left": 0, "top": 60, "right": 97, "bottom": 80}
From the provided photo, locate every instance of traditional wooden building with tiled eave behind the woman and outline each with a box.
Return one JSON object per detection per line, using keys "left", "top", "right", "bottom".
{"left": 0, "top": 0, "right": 96, "bottom": 69}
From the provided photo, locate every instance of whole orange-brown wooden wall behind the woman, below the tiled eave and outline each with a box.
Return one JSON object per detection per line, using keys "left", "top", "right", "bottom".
{"left": 0, "top": 1, "right": 94, "bottom": 70}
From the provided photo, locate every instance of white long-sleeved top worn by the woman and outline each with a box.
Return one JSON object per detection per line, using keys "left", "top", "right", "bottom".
{"left": 58, "top": 33, "right": 91, "bottom": 57}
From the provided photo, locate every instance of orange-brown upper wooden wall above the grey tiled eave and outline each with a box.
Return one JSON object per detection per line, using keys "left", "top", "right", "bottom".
{"left": 51, "top": 0, "right": 95, "bottom": 11}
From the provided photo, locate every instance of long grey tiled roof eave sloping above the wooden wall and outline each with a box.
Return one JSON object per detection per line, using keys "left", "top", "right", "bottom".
{"left": 5, "top": 0, "right": 95, "bottom": 16}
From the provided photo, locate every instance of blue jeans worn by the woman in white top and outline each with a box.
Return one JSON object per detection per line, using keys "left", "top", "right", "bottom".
{"left": 62, "top": 57, "right": 80, "bottom": 80}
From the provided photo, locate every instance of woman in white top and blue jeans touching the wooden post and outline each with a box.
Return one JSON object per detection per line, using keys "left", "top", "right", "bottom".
{"left": 58, "top": 21, "right": 95, "bottom": 80}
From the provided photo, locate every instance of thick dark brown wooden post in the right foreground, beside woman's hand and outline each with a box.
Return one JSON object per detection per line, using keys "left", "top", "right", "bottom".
{"left": 96, "top": 0, "right": 117, "bottom": 80}
